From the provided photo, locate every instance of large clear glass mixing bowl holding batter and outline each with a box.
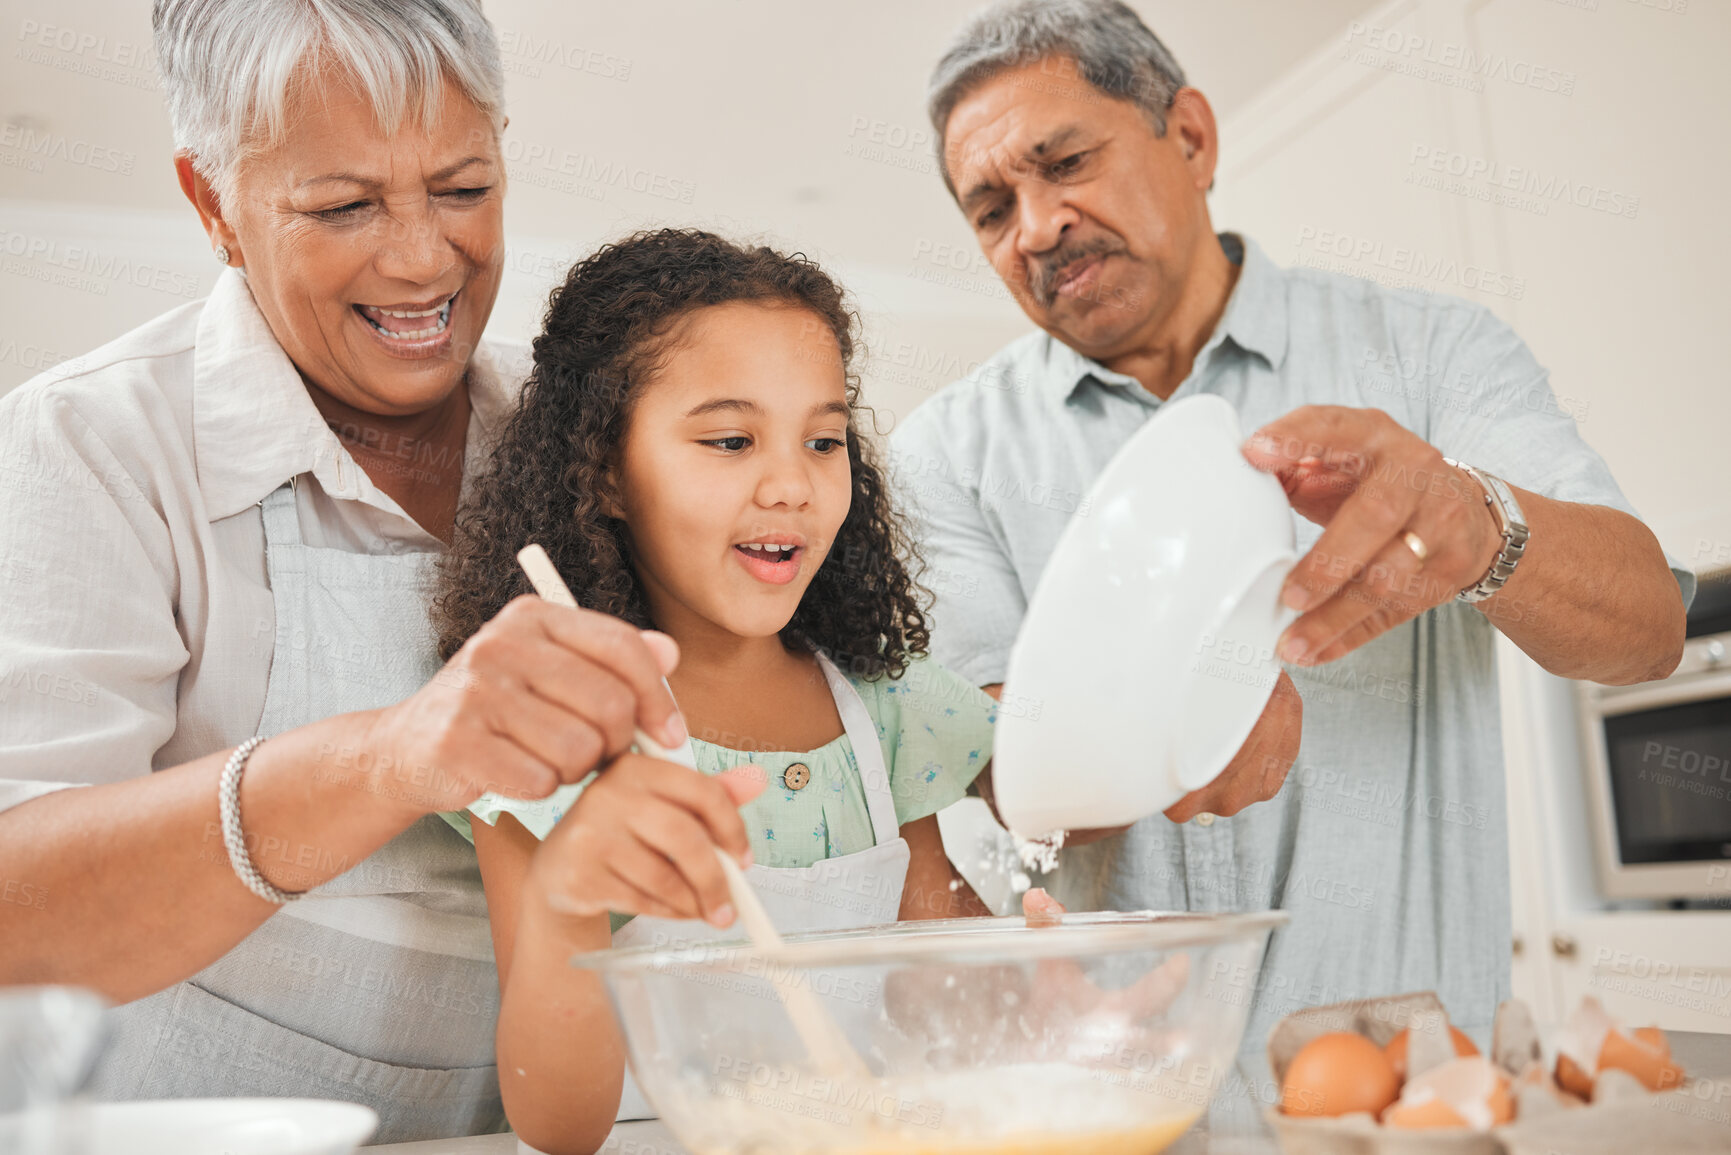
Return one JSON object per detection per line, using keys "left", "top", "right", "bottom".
{"left": 573, "top": 911, "right": 1286, "bottom": 1155}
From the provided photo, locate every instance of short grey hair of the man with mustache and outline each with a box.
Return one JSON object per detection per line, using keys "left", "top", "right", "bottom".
{"left": 926, "top": 0, "right": 1184, "bottom": 180}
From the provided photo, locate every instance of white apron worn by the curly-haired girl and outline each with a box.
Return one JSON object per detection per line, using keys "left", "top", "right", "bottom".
{"left": 613, "top": 655, "right": 909, "bottom": 1120}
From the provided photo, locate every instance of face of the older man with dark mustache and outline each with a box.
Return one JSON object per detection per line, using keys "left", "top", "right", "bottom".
{"left": 943, "top": 57, "right": 1213, "bottom": 360}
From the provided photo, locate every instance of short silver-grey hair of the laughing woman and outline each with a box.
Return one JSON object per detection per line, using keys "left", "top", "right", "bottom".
{"left": 151, "top": 0, "right": 505, "bottom": 196}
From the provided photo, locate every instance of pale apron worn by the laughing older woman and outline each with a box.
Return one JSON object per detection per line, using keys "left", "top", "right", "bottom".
{"left": 92, "top": 483, "right": 505, "bottom": 1143}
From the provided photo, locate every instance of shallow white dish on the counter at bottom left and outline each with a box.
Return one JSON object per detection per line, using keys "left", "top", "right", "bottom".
{"left": 80, "top": 1100, "right": 379, "bottom": 1155}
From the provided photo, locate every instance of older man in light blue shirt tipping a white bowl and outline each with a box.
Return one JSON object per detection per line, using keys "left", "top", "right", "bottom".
{"left": 893, "top": 0, "right": 1693, "bottom": 1048}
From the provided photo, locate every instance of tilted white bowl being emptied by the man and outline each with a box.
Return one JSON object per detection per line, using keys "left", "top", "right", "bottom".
{"left": 992, "top": 395, "right": 1297, "bottom": 838}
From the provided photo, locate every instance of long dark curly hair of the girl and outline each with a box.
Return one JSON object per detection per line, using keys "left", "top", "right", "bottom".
{"left": 433, "top": 229, "right": 930, "bottom": 679}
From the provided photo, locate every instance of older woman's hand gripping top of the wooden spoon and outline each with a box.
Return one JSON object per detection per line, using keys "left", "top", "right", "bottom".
{"left": 347, "top": 596, "right": 685, "bottom": 814}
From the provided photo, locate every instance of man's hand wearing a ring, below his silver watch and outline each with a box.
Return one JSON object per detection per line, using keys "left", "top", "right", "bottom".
{"left": 1245, "top": 405, "right": 1503, "bottom": 665}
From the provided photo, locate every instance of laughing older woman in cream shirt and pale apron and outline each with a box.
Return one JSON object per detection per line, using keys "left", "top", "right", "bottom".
{"left": 0, "top": 0, "right": 725, "bottom": 1141}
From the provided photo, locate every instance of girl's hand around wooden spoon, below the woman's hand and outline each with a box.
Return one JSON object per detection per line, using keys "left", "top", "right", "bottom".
{"left": 530, "top": 753, "right": 767, "bottom": 926}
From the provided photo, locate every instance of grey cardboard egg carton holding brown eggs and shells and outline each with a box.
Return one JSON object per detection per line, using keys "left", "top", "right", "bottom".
{"left": 1264, "top": 990, "right": 1731, "bottom": 1155}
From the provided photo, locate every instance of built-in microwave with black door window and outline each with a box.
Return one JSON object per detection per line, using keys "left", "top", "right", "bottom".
{"left": 1577, "top": 570, "right": 1731, "bottom": 900}
